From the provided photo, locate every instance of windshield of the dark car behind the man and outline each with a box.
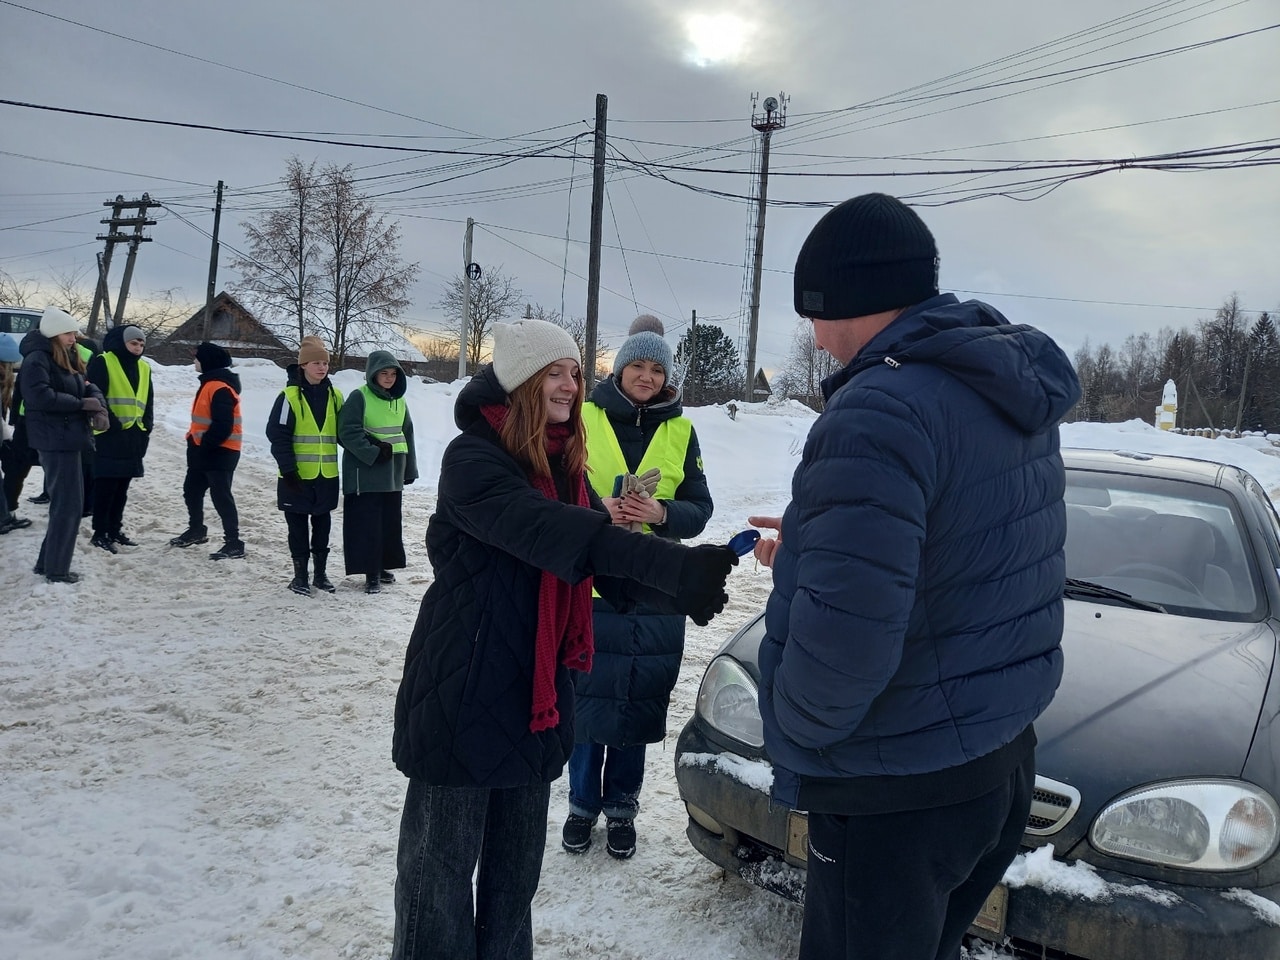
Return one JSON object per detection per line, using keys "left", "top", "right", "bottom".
{"left": 1066, "top": 470, "right": 1261, "bottom": 621}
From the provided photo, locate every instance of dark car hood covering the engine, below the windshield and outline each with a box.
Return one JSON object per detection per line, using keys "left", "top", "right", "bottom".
{"left": 1036, "top": 600, "right": 1276, "bottom": 850}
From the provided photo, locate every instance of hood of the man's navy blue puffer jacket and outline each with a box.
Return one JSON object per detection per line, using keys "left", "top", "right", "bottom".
{"left": 823, "top": 293, "right": 1080, "bottom": 434}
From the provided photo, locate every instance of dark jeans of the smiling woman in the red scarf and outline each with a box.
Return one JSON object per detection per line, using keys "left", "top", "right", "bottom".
{"left": 392, "top": 780, "right": 550, "bottom": 960}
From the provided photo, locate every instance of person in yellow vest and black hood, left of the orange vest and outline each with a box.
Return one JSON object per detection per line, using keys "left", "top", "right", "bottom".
{"left": 87, "top": 326, "right": 155, "bottom": 553}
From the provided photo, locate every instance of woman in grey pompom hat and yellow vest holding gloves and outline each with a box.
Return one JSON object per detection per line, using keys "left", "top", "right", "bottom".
{"left": 561, "top": 315, "right": 712, "bottom": 860}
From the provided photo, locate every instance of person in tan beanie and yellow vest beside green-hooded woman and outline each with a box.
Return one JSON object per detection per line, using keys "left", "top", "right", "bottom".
{"left": 266, "top": 337, "right": 342, "bottom": 596}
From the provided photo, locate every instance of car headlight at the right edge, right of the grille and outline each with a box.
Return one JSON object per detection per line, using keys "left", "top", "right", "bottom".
{"left": 1089, "top": 780, "right": 1280, "bottom": 870}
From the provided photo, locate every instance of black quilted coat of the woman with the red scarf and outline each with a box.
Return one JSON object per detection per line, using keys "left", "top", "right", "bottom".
{"left": 392, "top": 366, "right": 685, "bottom": 787}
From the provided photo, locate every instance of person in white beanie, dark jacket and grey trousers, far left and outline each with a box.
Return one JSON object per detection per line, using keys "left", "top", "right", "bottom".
{"left": 19, "top": 307, "right": 108, "bottom": 584}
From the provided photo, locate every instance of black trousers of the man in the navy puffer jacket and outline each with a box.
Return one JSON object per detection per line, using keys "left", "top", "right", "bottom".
{"left": 799, "top": 754, "right": 1036, "bottom": 960}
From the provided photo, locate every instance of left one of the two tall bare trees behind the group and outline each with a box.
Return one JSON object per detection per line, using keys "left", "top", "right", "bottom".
{"left": 232, "top": 156, "right": 323, "bottom": 340}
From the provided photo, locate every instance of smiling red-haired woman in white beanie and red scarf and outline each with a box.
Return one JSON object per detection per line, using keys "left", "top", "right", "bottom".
{"left": 392, "top": 320, "right": 737, "bottom": 960}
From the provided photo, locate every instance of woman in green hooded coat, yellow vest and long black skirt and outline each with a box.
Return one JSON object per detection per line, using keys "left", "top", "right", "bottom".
{"left": 338, "top": 349, "right": 417, "bottom": 594}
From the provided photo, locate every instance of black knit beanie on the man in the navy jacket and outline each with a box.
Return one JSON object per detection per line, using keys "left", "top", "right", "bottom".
{"left": 795, "top": 193, "right": 938, "bottom": 320}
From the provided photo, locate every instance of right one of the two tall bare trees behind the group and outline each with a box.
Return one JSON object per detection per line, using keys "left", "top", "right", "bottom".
{"left": 317, "top": 165, "right": 419, "bottom": 364}
